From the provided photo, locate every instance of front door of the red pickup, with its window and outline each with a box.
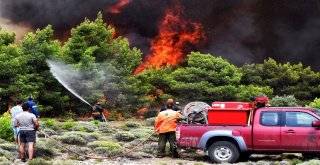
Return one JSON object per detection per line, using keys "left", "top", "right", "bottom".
{"left": 281, "top": 111, "right": 320, "bottom": 151}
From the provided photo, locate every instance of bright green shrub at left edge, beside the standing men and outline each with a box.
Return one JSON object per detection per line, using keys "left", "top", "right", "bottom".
{"left": 0, "top": 112, "right": 13, "bottom": 141}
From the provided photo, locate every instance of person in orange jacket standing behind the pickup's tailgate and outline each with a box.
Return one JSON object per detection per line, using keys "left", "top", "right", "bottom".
{"left": 154, "top": 102, "right": 183, "bottom": 158}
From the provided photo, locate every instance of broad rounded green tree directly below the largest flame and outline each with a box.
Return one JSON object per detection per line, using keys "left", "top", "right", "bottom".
{"left": 166, "top": 52, "right": 241, "bottom": 102}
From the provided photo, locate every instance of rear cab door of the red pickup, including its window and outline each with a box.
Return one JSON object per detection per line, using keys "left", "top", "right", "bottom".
{"left": 253, "top": 111, "right": 281, "bottom": 151}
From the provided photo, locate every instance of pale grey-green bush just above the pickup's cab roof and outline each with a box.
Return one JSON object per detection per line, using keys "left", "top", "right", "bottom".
{"left": 268, "top": 95, "right": 299, "bottom": 107}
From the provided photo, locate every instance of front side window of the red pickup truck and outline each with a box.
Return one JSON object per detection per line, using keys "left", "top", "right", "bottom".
{"left": 286, "top": 112, "right": 318, "bottom": 127}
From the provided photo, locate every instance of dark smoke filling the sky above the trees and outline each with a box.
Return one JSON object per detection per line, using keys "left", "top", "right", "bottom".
{"left": 0, "top": 0, "right": 320, "bottom": 70}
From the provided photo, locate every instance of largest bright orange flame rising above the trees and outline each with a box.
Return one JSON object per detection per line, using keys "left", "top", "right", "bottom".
{"left": 134, "top": 1, "right": 205, "bottom": 74}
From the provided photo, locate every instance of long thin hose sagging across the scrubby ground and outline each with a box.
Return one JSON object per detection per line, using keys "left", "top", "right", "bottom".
{"left": 38, "top": 117, "right": 176, "bottom": 159}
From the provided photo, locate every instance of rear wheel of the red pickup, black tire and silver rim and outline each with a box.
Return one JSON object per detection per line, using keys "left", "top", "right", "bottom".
{"left": 208, "top": 141, "right": 240, "bottom": 163}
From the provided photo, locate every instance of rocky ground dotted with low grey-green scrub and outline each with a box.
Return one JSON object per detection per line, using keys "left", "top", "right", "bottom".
{"left": 0, "top": 119, "right": 320, "bottom": 165}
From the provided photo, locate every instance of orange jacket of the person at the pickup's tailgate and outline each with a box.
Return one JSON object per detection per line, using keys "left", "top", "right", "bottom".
{"left": 154, "top": 109, "right": 183, "bottom": 133}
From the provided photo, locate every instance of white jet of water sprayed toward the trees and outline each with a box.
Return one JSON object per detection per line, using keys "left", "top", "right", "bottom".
{"left": 47, "top": 60, "right": 92, "bottom": 106}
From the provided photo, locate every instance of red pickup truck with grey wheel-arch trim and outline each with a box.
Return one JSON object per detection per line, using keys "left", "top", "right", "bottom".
{"left": 176, "top": 107, "right": 320, "bottom": 163}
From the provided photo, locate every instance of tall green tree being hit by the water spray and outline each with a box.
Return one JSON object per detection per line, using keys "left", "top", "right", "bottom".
{"left": 60, "top": 13, "right": 149, "bottom": 116}
